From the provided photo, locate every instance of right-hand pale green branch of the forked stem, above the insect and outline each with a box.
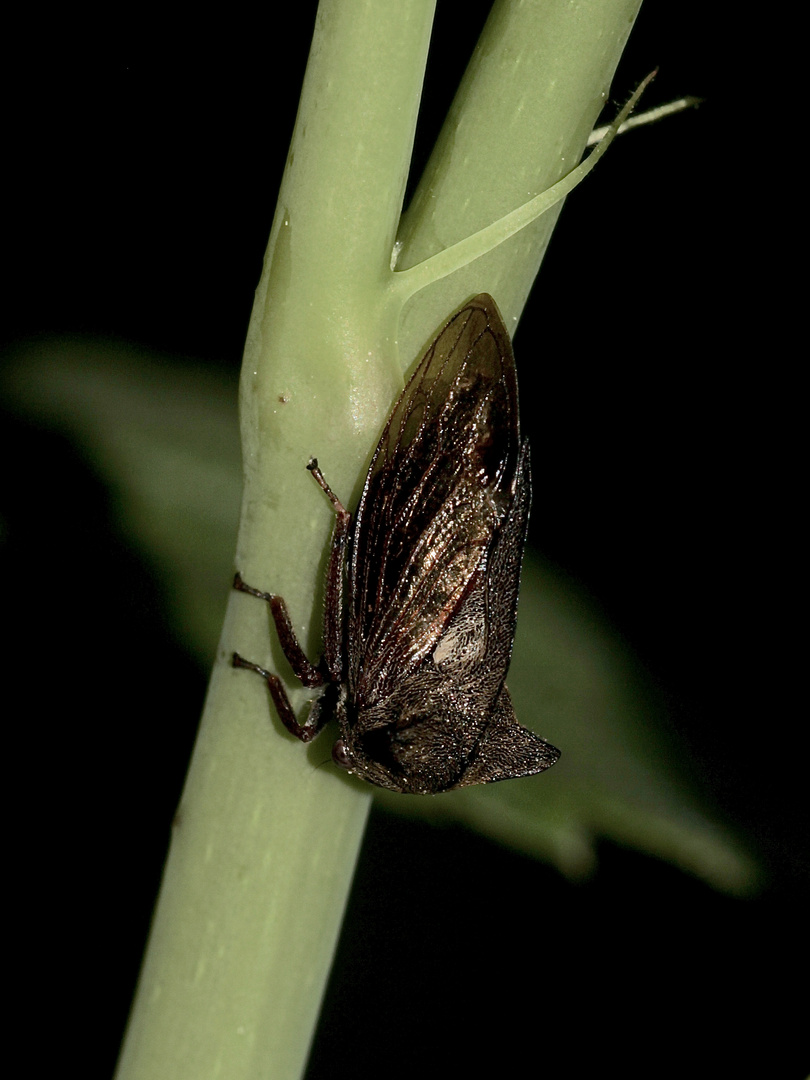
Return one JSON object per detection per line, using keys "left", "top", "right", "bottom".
{"left": 397, "top": 0, "right": 640, "bottom": 360}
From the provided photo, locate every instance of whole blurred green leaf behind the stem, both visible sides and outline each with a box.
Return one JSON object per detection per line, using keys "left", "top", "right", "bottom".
{"left": 4, "top": 342, "right": 758, "bottom": 893}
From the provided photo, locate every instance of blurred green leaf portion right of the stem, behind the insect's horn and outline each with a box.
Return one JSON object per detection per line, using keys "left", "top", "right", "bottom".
{"left": 383, "top": 553, "right": 757, "bottom": 893}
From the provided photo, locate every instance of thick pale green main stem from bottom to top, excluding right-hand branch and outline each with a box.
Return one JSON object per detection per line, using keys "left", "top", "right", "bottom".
{"left": 118, "top": 0, "right": 433, "bottom": 1080}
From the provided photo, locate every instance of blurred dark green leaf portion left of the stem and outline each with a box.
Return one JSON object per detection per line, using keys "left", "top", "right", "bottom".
{"left": 3, "top": 340, "right": 242, "bottom": 669}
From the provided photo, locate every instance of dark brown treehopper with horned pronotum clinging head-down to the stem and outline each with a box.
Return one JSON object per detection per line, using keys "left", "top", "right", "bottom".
{"left": 233, "top": 294, "right": 559, "bottom": 794}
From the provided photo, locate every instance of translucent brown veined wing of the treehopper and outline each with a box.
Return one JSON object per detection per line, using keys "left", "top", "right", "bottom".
{"left": 347, "top": 294, "right": 521, "bottom": 707}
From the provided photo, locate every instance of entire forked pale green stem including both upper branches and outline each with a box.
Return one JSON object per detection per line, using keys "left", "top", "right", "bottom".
{"left": 117, "top": 0, "right": 639, "bottom": 1080}
